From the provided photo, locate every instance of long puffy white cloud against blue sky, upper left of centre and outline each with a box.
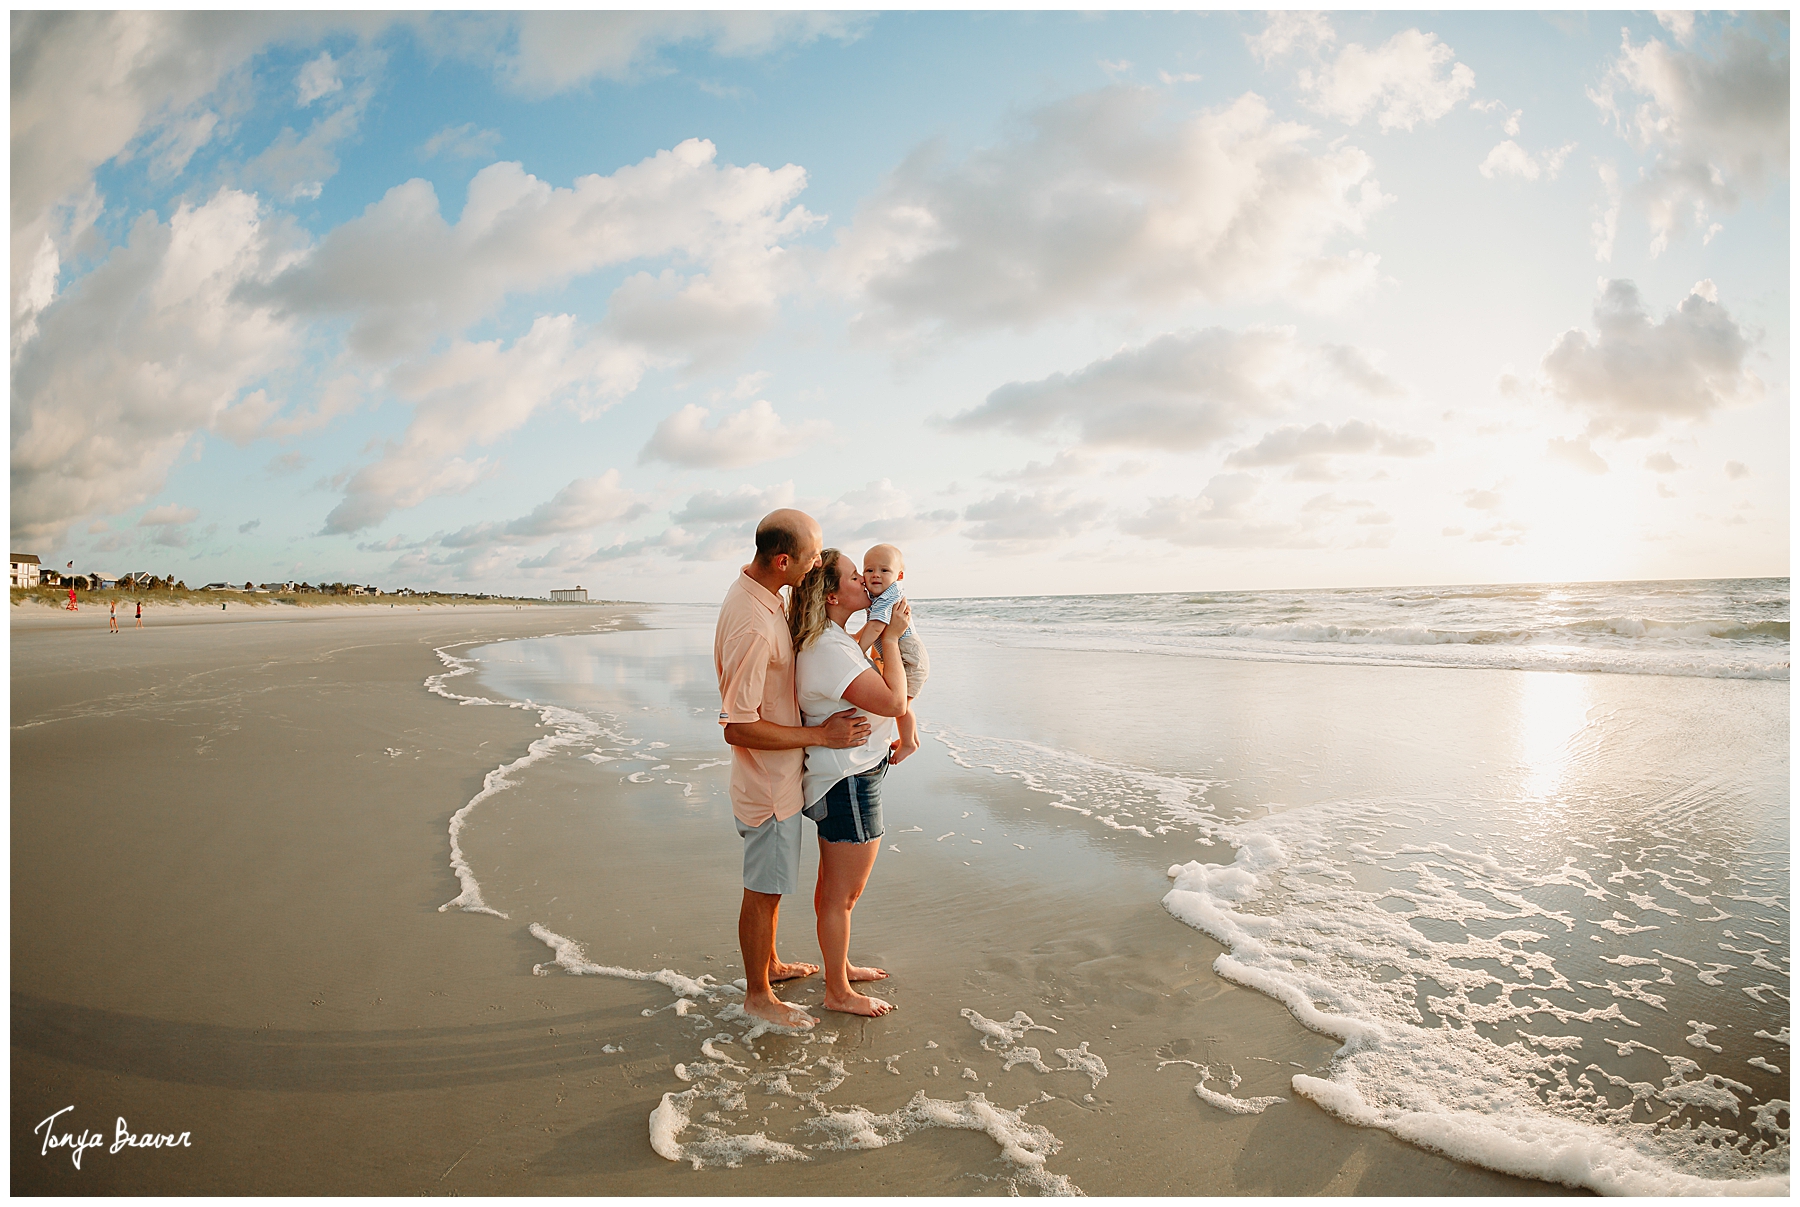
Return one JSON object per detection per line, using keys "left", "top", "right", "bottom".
{"left": 272, "top": 139, "right": 817, "bottom": 356}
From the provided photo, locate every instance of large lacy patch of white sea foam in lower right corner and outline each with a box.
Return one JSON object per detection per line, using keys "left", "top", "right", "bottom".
{"left": 1165, "top": 802, "right": 1787, "bottom": 1194}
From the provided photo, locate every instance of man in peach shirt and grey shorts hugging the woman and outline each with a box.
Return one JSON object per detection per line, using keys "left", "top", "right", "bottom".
{"left": 713, "top": 507, "right": 869, "bottom": 1027}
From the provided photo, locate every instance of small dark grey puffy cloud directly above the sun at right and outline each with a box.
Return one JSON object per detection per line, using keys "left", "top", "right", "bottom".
{"left": 1543, "top": 281, "right": 1762, "bottom": 435}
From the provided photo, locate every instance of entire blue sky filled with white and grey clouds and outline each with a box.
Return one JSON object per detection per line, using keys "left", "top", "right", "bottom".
{"left": 11, "top": 13, "right": 1789, "bottom": 601}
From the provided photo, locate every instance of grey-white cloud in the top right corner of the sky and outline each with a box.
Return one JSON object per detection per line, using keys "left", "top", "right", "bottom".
{"left": 1588, "top": 13, "right": 1787, "bottom": 255}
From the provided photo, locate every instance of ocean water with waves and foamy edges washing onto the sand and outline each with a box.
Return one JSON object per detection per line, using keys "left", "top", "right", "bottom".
{"left": 434, "top": 579, "right": 1791, "bottom": 1194}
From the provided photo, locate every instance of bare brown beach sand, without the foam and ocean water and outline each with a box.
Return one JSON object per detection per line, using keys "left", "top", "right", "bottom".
{"left": 11, "top": 606, "right": 1561, "bottom": 1194}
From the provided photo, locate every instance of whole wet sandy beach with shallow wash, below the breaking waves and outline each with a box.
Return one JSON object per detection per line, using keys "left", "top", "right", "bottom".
{"left": 13, "top": 590, "right": 1787, "bottom": 1196}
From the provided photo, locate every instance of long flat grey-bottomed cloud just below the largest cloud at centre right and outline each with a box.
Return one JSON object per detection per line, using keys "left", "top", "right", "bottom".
{"left": 950, "top": 327, "right": 1397, "bottom": 450}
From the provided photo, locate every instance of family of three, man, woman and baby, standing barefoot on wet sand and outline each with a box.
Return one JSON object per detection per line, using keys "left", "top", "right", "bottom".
{"left": 713, "top": 509, "right": 931, "bottom": 1027}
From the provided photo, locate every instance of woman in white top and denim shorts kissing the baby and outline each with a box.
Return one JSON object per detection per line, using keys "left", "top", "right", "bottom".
{"left": 788, "top": 549, "right": 913, "bottom": 1018}
